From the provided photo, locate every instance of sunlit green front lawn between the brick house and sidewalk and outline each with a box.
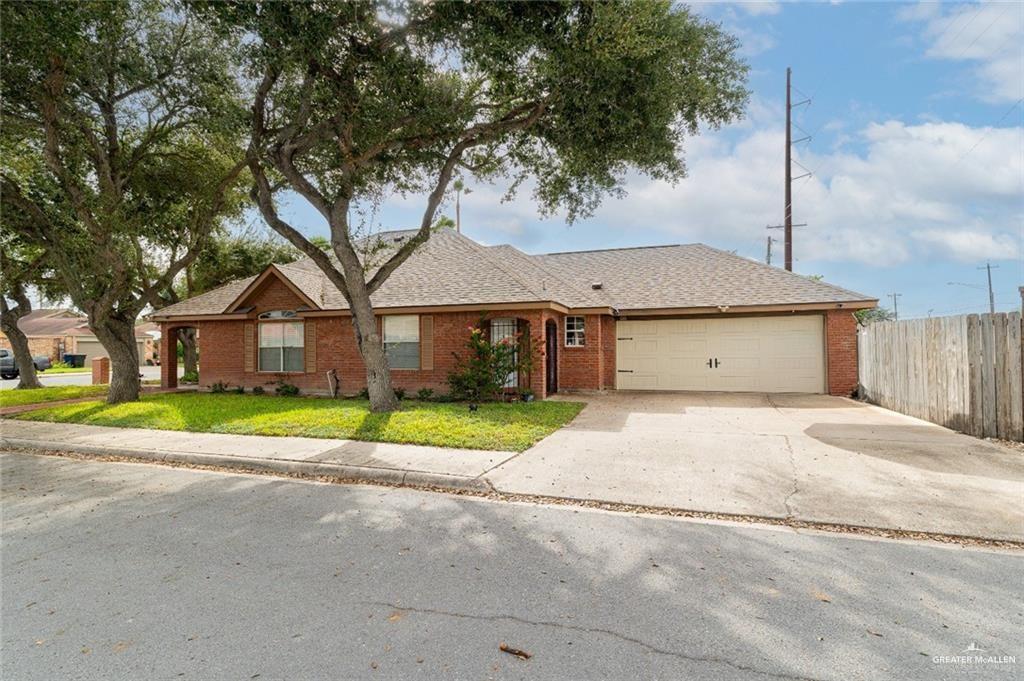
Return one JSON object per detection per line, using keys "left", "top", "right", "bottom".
{"left": 16, "top": 388, "right": 583, "bottom": 452}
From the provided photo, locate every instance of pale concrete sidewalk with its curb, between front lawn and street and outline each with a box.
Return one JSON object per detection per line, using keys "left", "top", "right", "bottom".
{"left": 0, "top": 419, "right": 515, "bottom": 491}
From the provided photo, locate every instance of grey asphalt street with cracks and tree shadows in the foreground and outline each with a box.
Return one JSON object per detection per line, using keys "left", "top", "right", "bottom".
{"left": 0, "top": 453, "right": 1024, "bottom": 681}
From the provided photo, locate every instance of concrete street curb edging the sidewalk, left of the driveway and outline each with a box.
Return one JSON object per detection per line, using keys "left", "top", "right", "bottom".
{"left": 0, "top": 436, "right": 492, "bottom": 492}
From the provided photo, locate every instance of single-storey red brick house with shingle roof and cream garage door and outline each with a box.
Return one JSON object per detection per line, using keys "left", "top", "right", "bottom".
{"left": 153, "top": 229, "right": 878, "bottom": 397}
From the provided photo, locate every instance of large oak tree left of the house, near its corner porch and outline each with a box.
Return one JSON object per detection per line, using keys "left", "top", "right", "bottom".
{"left": 0, "top": 0, "right": 245, "bottom": 402}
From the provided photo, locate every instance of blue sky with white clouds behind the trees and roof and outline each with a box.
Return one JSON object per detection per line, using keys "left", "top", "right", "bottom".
{"left": 274, "top": 2, "right": 1024, "bottom": 318}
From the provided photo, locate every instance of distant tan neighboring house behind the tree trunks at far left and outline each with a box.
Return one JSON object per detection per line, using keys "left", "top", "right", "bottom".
{"left": 0, "top": 309, "right": 159, "bottom": 365}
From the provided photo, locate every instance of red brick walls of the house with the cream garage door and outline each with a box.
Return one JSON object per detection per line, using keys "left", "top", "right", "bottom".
{"left": 161, "top": 278, "right": 857, "bottom": 398}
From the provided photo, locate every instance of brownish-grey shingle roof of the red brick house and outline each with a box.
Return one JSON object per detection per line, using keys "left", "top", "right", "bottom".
{"left": 149, "top": 229, "right": 873, "bottom": 317}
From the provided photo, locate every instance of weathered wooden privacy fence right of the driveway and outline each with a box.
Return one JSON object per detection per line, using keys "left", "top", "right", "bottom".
{"left": 857, "top": 312, "right": 1024, "bottom": 440}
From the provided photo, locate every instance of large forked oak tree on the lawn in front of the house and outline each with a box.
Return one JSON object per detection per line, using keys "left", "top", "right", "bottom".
{"left": 193, "top": 0, "right": 748, "bottom": 411}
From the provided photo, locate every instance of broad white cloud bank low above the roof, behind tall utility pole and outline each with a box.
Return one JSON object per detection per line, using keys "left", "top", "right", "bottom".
{"left": 463, "top": 111, "right": 1024, "bottom": 265}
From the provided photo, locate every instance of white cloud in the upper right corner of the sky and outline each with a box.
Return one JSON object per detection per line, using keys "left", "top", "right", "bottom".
{"left": 900, "top": 2, "right": 1024, "bottom": 102}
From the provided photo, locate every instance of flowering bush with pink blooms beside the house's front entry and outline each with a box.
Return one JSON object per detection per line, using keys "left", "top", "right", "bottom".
{"left": 447, "top": 318, "right": 532, "bottom": 401}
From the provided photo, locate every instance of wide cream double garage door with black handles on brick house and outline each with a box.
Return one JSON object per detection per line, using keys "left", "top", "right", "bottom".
{"left": 615, "top": 314, "right": 825, "bottom": 392}
